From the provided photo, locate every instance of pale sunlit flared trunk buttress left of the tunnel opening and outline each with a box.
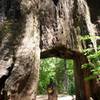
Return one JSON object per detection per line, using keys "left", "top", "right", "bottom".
{"left": 4, "top": 12, "right": 40, "bottom": 100}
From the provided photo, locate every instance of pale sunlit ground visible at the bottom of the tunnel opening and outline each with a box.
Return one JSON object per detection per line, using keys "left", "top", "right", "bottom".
{"left": 36, "top": 94, "right": 75, "bottom": 100}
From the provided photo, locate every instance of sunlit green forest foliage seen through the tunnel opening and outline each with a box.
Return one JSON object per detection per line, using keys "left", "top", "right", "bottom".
{"left": 38, "top": 58, "right": 75, "bottom": 94}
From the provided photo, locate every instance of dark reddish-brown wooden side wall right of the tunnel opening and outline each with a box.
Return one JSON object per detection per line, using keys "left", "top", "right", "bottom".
{"left": 74, "top": 53, "right": 90, "bottom": 100}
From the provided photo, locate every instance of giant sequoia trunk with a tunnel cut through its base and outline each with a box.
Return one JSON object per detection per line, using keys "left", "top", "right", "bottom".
{"left": 0, "top": 0, "right": 100, "bottom": 100}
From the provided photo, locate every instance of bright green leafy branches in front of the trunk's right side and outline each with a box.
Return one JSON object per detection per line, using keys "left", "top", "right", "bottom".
{"left": 82, "top": 36, "right": 100, "bottom": 80}
